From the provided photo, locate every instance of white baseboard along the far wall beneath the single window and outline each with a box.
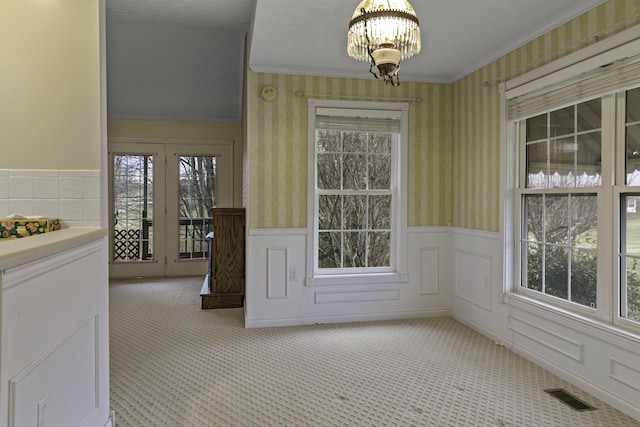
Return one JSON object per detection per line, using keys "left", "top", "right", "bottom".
{"left": 244, "top": 310, "right": 450, "bottom": 329}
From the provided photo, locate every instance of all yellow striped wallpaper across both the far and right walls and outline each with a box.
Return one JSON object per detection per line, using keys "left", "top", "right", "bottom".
{"left": 246, "top": 0, "right": 640, "bottom": 232}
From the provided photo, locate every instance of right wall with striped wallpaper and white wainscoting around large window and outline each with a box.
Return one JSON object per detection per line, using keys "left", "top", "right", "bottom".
{"left": 450, "top": 0, "right": 640, "bottom": 420}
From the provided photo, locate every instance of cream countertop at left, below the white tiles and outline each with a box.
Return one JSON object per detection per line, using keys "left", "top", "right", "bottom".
{"left": 0, "top": 227, "right": 107, "bottom": 271}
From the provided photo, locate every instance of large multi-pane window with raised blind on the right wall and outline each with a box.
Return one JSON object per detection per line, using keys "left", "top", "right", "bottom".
{"left": 505, "top": 36, "right": 640, "bottom": 331}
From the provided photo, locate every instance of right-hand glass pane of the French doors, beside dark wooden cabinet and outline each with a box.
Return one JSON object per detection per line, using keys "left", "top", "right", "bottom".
{"left": 178, "top": 156, "right": 216, "bottom": 259}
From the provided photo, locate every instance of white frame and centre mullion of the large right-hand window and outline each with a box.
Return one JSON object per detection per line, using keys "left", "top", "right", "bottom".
{"left": 500, "top": 27, "right": 640, "bottom": 334}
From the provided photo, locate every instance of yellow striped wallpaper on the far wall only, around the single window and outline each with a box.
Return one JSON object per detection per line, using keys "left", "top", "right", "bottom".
{"left": 247, "top": 70, "right": 452, "bottom": 228}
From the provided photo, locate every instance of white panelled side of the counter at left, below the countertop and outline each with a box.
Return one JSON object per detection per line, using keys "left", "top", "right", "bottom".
{"left": 0, "top": 237, "right": 109, "bottom": 427}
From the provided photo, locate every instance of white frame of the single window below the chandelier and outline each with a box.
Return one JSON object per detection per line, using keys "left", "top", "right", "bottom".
{"left": 305, "top": 98, "right": 409, "bottom": 286}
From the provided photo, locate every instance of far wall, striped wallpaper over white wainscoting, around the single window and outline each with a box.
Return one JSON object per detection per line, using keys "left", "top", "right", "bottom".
{"left": 246, "top": 71, "right": 452, "bottom": 327}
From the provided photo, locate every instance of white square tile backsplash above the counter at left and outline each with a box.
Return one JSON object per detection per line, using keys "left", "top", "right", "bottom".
{"left": 0, "top": 169, "right": 100, "bottom": 227}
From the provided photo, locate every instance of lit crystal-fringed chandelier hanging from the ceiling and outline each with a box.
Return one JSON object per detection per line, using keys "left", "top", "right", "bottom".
{"left": 347, "top": 0, "right": 420, "bottom": 86}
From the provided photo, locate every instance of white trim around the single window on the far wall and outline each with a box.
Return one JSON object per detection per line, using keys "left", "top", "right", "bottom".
{"left": 305, "top": 98, "right": 409, "bottom": 286}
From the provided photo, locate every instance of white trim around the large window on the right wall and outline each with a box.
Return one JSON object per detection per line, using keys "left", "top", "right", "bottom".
{"left": 500, "top": 26, "right": 640, "bottom": 333}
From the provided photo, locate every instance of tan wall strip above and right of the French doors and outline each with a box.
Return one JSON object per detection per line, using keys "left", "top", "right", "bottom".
{"left": 107, "top": 119, "right": 243, "bottom": 206}
